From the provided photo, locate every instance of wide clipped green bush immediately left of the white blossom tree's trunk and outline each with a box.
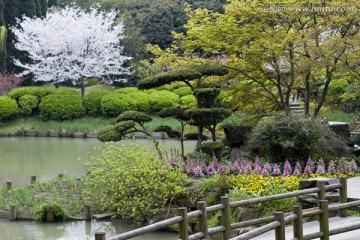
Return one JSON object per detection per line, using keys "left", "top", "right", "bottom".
{"left": 39, "top": 94, "right": 85, "bottom": 120}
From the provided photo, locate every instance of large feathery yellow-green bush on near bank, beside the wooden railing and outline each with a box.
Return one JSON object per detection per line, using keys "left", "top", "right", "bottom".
{"left": 86, "top": 144, "right": 186, "bottom": 223}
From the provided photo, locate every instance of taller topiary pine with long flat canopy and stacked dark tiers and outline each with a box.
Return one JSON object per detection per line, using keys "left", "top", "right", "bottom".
{"left": 137, "top": 64, "right": 231, "bottom": 149}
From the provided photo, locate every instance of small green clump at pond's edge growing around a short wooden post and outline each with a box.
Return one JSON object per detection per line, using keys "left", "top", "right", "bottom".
{"left": 35, "top": 202, "right": 67, "bottom": 222}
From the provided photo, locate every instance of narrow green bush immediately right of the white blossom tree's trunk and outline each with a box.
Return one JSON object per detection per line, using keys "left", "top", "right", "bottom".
{"left": 83, "top": 90, "right": 110, "bottom": 116}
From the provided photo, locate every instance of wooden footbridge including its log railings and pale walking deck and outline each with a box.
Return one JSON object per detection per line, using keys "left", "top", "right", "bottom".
{"left": 95, "top": 177, "right": 360, "bottom": 240}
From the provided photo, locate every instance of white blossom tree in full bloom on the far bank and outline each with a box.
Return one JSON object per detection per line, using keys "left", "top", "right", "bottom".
{"left": 11, "top": 6, "right": 131, "bottom": 95}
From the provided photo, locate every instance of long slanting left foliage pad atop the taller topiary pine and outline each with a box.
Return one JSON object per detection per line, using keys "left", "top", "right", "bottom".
{"left": 137, "top": 69, "right": 202, "bottom": 89}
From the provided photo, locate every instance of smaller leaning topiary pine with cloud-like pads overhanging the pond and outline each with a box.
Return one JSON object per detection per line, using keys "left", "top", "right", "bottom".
{"left": 97, "top": 111, "right": 163, "bottom": 159}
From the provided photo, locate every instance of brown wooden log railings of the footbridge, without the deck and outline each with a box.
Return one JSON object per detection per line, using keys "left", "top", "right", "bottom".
{"left": 95, "top": 178, "right": 360, "bottom": 240}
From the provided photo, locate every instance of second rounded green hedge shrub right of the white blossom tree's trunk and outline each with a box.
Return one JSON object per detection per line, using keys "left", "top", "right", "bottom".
{"left": 101, "top": 93, "right": 136, "bottom": 116}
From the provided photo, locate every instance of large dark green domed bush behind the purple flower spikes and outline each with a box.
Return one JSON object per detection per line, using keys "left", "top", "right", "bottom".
{"left": 251, "top": 116, "right": 347, "bottom": 163}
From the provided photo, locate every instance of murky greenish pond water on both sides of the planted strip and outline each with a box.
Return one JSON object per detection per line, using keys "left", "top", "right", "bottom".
{"left": 0, "top": 137, "right": 195, "bottom": 240}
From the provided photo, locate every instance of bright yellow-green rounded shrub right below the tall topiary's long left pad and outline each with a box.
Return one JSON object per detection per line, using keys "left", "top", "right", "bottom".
{"left": 149, "top": 90, "right": 179, "bottom": 112}
